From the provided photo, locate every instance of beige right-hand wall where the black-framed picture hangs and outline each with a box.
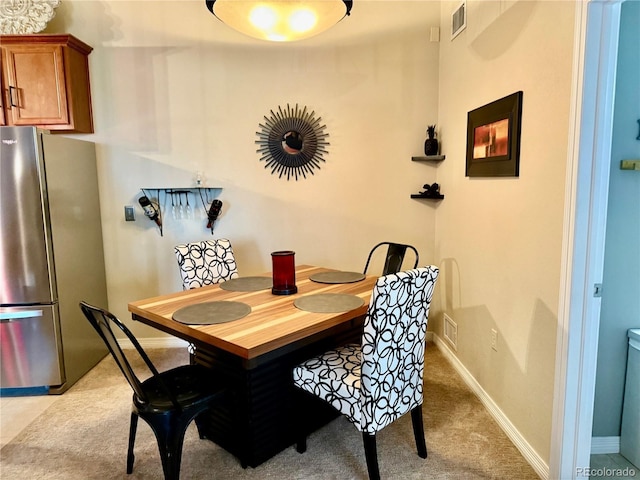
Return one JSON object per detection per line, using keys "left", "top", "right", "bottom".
{"left": 431, "top": 1, "right": 574, "bottom": 463}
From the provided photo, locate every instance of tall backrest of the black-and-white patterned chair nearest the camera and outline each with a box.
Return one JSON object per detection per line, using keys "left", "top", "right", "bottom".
{"left": 360, "top": 265, "right": 439, "bottom": 433}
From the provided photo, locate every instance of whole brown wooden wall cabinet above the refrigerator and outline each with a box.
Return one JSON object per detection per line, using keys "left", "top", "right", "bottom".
{"left": 0, "top": 34, "right": 93, "bottom": 133}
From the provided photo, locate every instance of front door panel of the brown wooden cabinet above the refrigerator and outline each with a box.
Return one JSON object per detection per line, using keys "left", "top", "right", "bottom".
{"left": 3, "top": 45, "right": 69, "bottom": 125}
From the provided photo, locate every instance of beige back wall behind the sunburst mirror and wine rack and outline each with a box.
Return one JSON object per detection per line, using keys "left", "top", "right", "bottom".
{"left": 47, "top": 0, "right": 440, "bottom": 337}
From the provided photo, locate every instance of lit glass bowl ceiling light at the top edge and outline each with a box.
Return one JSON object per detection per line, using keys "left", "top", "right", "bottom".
{"left": 205, "top": 0, "right": 353, "bottom": 42}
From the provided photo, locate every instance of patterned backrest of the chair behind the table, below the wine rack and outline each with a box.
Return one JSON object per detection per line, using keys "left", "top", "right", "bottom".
{"left": 174, "top": 238, "right": 238, "bottom": 290}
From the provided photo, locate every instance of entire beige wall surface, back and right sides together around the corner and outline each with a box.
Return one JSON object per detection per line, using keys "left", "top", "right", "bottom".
{"left": 47, "top": 0, "right": 574, "bottom": 470}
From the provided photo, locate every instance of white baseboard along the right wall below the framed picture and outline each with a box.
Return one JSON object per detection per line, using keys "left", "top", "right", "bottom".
{"left": 427, "top": 332, "right": 549, "bottom": 480}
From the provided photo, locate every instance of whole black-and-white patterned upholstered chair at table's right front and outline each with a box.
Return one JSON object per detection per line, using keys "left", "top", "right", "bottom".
{"left": 293, "top": 265, "right": 439, "bottom": 480}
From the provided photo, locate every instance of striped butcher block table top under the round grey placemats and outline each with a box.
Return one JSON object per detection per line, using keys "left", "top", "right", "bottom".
{"left": 129, "top": 265, "right": 378, "bottom": 360}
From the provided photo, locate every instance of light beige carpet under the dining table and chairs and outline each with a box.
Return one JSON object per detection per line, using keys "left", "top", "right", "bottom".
{"left": 0, "top": 344, "right": 538, "bottom": 480}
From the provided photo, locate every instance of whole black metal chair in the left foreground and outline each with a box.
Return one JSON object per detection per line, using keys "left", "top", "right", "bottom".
{"left": 80, "top": 302, "right": 224, "bottom": 480}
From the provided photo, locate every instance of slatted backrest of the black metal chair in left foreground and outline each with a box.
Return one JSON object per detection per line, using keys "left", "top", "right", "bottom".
{"left": 80, "top": 302, "right": 179, "bottom": 408}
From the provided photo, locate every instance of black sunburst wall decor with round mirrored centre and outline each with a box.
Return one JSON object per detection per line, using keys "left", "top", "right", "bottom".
{"left": 256, "top": 104, "right": 329, "bottom": 180}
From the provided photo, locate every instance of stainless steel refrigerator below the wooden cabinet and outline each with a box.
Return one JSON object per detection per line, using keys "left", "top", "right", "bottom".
{"left": 0, "top": 127, "right": 107, "bottom": 395}
